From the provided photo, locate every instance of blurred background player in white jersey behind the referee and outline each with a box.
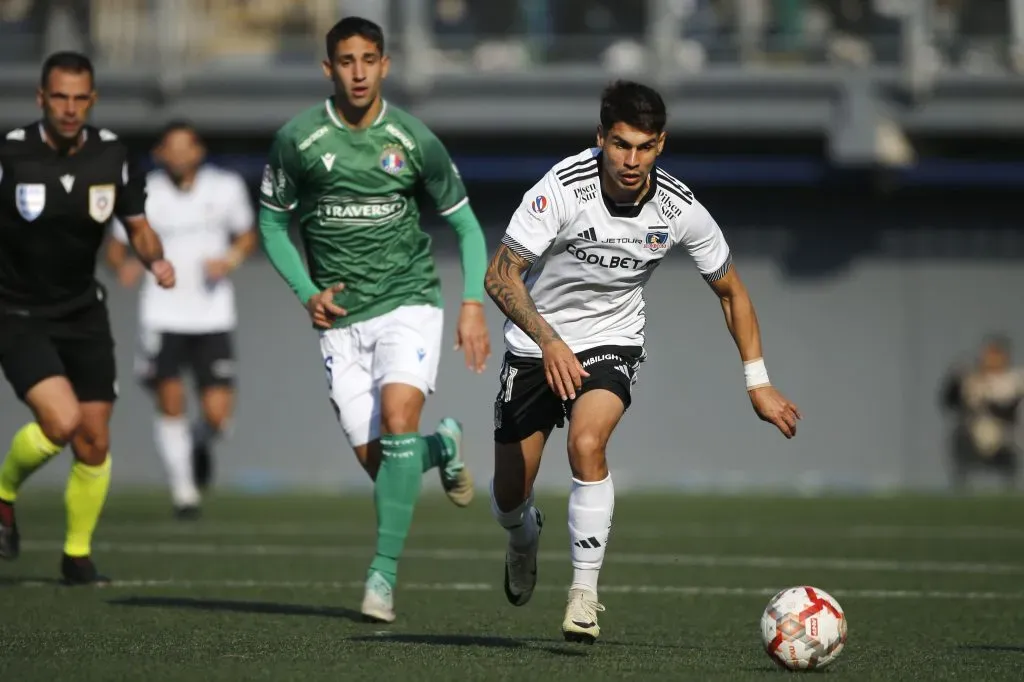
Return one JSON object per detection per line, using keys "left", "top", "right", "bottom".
{"left": 108, "top": 121, "right": 257, "bottom": 519}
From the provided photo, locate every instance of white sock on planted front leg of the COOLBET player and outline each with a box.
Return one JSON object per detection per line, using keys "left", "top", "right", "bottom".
{"left": 569, "top": 474, "right": 615, "bottom": 594}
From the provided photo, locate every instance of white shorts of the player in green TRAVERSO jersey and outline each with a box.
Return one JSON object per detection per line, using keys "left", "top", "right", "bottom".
{"left": 321, "top": 305, "right": 444, "bottom": 447}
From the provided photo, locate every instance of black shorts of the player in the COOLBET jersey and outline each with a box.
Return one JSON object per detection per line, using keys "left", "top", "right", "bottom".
{"left": 495, "top": 346, "right": 644, "bottom": 443}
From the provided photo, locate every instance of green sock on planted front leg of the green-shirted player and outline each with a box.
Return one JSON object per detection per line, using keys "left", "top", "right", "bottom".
{"left": 369, "top": 433, "right": 428, "bottom": 587}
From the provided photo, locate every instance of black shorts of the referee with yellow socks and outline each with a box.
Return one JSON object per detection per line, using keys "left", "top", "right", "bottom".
{"left": 0, "top": 301, "right": 118, "bottom": 402}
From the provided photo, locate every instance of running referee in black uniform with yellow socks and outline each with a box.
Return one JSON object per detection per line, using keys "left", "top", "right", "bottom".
{"left": 0, "top": 52, "right": 174, "bottom": 585}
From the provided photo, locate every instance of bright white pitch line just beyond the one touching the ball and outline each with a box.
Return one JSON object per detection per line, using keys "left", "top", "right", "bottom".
{"left": 14, "top": 541, "right": 1024, "bottom": 576}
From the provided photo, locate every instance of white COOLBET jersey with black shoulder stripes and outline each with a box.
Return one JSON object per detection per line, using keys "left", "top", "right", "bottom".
{"left": 502, "top": 148, "right": 732, "bottom": 357}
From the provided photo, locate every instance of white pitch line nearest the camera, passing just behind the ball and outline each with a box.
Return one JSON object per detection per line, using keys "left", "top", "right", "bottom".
{"left": 6, "top": 579, "right": 1024, "bottom": 601}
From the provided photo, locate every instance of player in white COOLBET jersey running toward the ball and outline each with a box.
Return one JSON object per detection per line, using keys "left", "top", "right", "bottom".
{"left": 486, "top": 81, "right": 800, "bottom": 643}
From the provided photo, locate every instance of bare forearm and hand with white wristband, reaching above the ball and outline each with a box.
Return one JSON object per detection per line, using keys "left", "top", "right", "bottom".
{"left": 710, "top": 264, "right": 802, "bottom": 438}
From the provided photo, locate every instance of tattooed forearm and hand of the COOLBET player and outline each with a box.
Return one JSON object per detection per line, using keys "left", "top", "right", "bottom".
{"left": 483, "top": 244, "right": 590, "bottom": 400}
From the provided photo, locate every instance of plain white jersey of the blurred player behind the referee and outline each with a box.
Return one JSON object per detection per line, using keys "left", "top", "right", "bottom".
{"left": 114, "top": 166, "right": 255, "bottom": 334}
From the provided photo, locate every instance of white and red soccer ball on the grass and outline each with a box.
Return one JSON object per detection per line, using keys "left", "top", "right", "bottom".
{"left": 761, "top": 586, "right": 846, "bottom": 670}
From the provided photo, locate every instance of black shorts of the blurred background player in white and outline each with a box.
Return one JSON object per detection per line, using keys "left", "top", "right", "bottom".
{"left": 135, "top": 331, "right": 234, "bottom": 390}
